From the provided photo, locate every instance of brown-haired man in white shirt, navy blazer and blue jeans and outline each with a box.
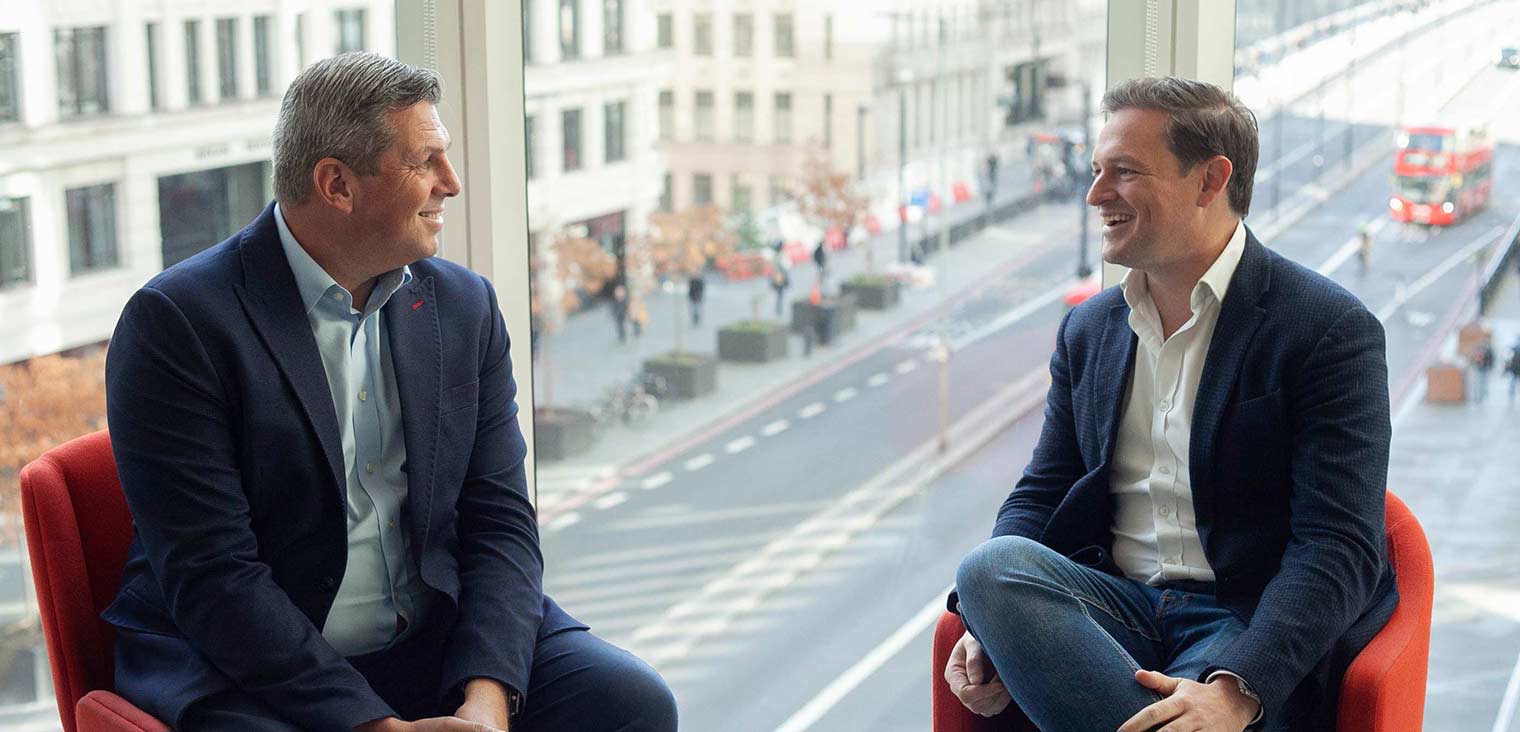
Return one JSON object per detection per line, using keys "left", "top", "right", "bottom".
{"left": 945, "top": 77, "right": 1398, "bottom": 732}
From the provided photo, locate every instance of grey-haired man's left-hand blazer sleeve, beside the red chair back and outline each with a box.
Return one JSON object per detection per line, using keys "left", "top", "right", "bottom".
{"left": 106, "top": 287, "right": 394, "bottom": 730}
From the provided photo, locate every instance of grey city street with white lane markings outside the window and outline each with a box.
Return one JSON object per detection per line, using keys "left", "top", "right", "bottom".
{"left": 541, "top": 6, "right": 1520, "bottom": 732}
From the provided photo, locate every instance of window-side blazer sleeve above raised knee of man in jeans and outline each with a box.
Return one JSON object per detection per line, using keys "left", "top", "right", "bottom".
{"left": 993, "top": 310, "right": 1087, "bottom": 541}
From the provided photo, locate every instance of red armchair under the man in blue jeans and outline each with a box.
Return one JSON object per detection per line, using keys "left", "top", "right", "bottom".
{"left": 933, "top": 494, "right": 1435, "bottom": 732}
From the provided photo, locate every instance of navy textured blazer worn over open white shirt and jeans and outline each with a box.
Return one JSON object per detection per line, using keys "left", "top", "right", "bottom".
{"left": 993, "top": 231, "right": 1398, "bottom": 729}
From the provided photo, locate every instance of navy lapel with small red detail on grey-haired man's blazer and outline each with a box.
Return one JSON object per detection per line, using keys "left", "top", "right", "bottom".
{"left": 382, "top": 266, "right": 442, "bottom": 551}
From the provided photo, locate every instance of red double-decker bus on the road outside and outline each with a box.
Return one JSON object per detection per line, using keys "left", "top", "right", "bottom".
{"left": 1388, "top": 125, "right": 1494, "bottom": 226}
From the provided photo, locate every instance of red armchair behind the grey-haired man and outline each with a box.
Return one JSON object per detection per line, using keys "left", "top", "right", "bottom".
{"left": 21, "top": 430, "right": 169, "bottom": 732}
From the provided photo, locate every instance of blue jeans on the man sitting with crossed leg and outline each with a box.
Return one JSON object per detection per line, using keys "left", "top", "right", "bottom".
{"left": 956, "top": 536, "right": 1284, "bottom": 732}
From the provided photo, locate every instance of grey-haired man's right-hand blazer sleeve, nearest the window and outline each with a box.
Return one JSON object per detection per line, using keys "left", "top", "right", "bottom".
{"left": 442, "top": 279, "right": 544, "bottom": 694}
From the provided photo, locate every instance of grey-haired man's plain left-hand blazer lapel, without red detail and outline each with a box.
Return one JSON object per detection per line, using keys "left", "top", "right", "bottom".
{"left": 237, "top": 204, "right": 347, "bottom": 506}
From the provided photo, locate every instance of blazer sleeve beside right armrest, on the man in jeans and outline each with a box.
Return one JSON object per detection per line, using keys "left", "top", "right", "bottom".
{"left": 1204, "top": 307, "right": 1392, "bottom": 722}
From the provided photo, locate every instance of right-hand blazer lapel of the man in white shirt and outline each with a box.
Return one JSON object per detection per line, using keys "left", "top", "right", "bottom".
{"left": 1187, "top": 229, "right": 1271, "bottom": 547}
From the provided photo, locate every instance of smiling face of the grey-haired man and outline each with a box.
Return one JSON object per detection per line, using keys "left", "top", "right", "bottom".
{"left": 351, "top": 102, "right": 459, "bottom": 276}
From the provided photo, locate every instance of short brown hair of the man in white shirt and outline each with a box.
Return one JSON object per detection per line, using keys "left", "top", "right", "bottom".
{"left": 1104, "top": 76, "right": 1259, "bottom": 219}
